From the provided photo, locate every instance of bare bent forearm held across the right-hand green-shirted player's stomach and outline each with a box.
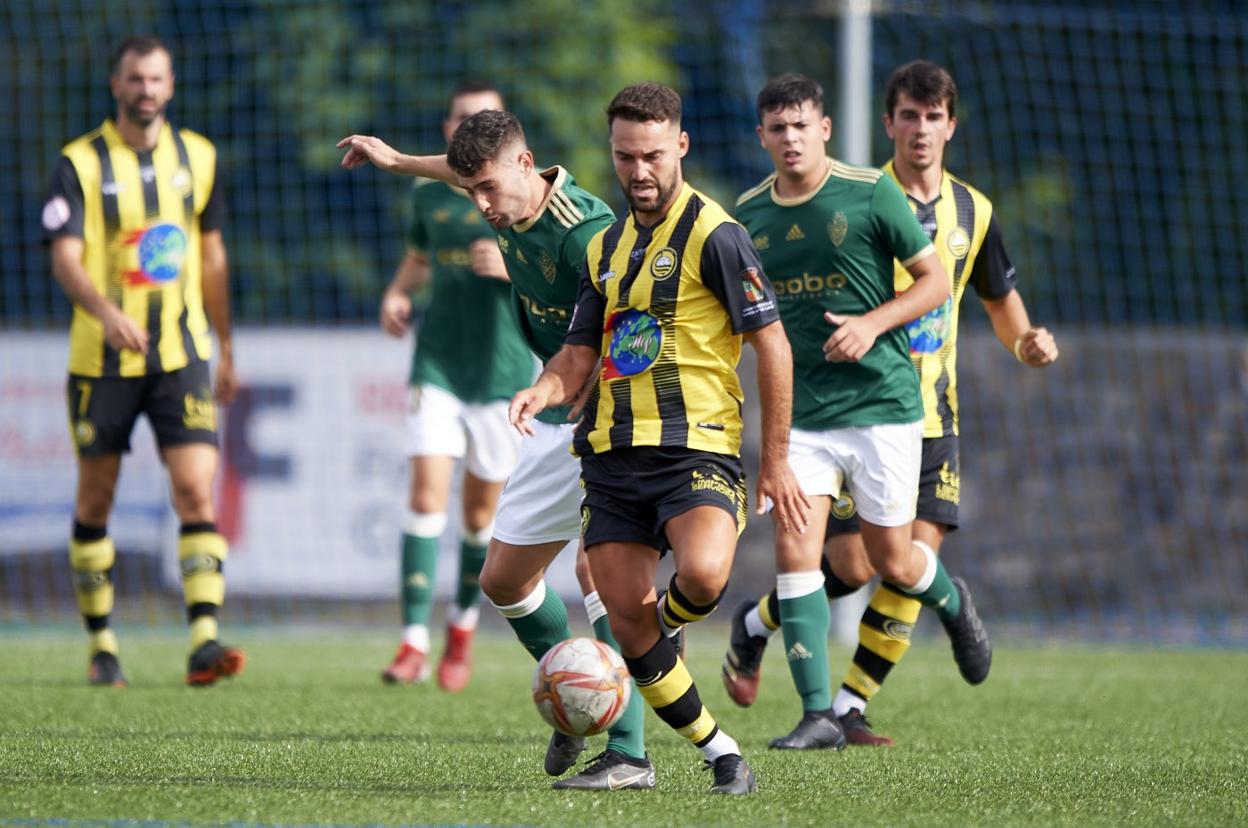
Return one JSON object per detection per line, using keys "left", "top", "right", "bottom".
{"left": 824, "top": 252, "right": 948, "bottom": 362}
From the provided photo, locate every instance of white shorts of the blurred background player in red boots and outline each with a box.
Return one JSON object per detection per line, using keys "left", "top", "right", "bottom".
{"left": 407, "top": 385, "right": 520, "bottom": 483}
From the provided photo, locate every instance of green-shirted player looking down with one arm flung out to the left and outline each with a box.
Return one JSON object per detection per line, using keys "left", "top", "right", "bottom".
{"left": 339, "top": 111, "right": 654, "bottom": 789}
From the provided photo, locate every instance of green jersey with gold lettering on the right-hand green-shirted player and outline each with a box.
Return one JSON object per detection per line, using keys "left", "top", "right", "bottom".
{"left": 736, "top": 159, "right": 932, "bottom": 431}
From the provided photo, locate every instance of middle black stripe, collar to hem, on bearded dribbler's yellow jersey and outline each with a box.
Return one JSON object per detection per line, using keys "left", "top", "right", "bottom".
{"left": 650, "top": 195, "right": 703, "bottom": 446}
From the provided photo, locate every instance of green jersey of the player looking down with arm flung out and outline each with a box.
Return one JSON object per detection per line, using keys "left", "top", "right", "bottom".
{"left": 498, "top": 166, "right": 614, "bottom": 423}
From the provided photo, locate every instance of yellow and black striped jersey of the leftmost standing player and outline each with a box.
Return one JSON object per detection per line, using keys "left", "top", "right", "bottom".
{"left": 42, "top": 120, "right": 223, "bottom": 377}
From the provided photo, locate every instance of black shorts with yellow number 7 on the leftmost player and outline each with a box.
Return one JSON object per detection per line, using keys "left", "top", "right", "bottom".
{"left": 67, "top": 362, "right": 217, "bottom": 457}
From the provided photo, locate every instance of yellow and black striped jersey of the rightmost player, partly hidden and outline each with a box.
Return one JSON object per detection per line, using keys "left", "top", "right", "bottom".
{"left": 884, "top": 161, "right": 1016, "bottom": 437}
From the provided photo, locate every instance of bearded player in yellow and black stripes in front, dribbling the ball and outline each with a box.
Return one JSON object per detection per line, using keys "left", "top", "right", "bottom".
{"left": 510, "top": 84, "right": 809, "bottom": 794}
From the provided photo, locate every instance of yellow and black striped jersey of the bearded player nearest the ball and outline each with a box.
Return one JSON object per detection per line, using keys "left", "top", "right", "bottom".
{"left": 564, "top": 184, "right": 780, "bottom": 457}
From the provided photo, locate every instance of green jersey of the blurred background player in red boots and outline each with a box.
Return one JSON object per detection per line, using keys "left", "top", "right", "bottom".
{"left": 407, "top": 181, "right": 533, "bottom": 403}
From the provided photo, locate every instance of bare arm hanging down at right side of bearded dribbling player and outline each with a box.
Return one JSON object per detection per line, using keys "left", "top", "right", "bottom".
{"left": 745, "top": 322, "right": 810, "bottom": 535}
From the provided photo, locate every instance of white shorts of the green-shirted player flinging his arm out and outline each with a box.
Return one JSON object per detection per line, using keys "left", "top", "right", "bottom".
{"left": 494, "top": 421, "right": 583, "bottom": 546}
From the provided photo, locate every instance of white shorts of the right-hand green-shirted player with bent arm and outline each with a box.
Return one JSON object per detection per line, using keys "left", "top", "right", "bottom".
{"left": 789, "top": 421, "right": 924, "bottom": 526}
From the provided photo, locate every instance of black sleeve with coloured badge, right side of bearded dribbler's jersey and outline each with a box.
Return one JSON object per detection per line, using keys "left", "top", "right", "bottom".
{"left": 701, "top": 221, "right": 780, "bottom": 333}
